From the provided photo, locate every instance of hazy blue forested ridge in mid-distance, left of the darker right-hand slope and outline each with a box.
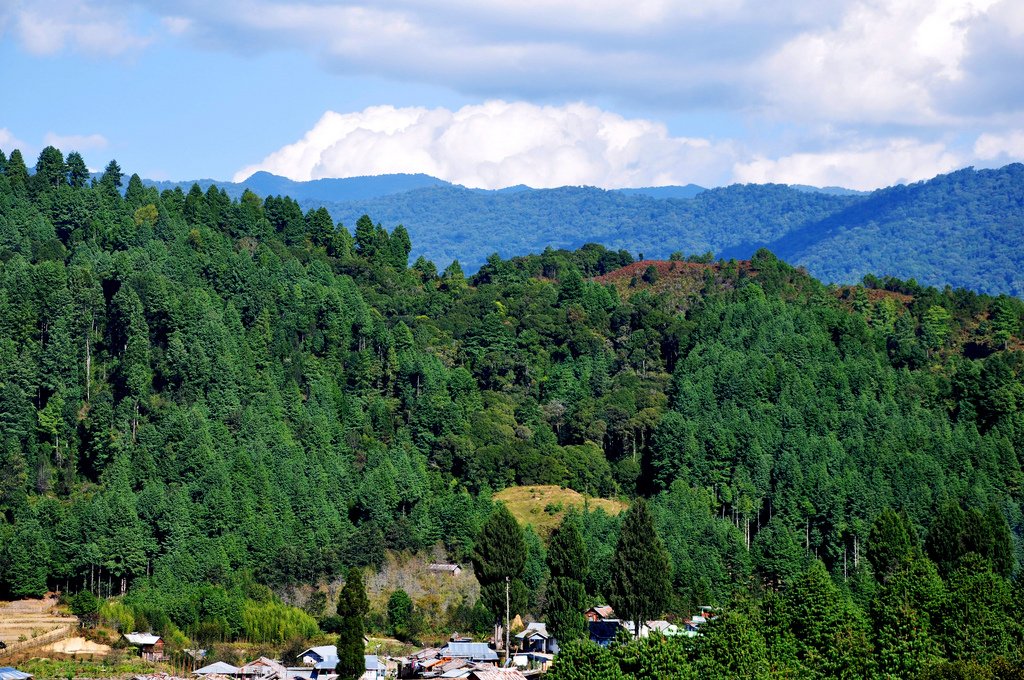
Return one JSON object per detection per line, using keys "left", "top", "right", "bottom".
{"left": 313, "top": 184, "right": 852, "bottom": 270}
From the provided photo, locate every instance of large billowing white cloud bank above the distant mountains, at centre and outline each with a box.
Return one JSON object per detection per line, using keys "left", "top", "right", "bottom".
{"left": 234, "top": 100, "right": 734, "bottom": 188}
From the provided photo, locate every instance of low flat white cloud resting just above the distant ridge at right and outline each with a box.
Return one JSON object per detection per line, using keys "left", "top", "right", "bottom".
{"left": 733, "top": 138, "right": 964, "bottom": 190}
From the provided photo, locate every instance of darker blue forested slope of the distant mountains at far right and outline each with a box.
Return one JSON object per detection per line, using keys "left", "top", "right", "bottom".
{"left": 766, "top": 164, "right": 1024, "bottom": 297}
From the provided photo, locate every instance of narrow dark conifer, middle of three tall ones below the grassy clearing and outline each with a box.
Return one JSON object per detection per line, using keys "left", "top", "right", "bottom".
{"left": 546, "top": 514, "right": 588, "bottom": 643}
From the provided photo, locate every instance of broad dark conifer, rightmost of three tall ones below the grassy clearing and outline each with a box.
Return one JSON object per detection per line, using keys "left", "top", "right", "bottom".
{"left": 607, "top": 499, "right": 672, "bottom": 637}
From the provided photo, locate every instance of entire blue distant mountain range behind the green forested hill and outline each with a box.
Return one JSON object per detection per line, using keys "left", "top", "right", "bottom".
{"left": 146, "top": 164, "right": 1024, "bottom": 296}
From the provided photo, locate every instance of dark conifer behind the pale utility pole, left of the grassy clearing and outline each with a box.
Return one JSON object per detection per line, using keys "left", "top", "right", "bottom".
{"left": 472, "top": 504, "right": 528, "bottom": 623}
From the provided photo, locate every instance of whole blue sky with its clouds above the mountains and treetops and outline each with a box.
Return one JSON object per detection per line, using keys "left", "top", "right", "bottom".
{"left": 0, "top": 0, "right": 1024, "bottom": 188}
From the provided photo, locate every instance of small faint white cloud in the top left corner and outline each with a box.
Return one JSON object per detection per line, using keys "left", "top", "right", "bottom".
{"left": 0, "top": 0, "right": 151, "bottom": 56}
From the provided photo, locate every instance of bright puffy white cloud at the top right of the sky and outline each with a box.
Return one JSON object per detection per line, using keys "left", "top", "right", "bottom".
{"left": 760, "top": 0, "right": 996, "bottom": 125}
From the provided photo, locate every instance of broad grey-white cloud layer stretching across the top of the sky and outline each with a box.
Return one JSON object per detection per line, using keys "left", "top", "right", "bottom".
{"left": 8, "top": 0, "right": 1024, "bottom": 126}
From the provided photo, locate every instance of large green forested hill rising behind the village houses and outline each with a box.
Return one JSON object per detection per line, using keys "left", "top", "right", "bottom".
{"left": 0, "top": 147, "right": 1024, "bottom": 677}
